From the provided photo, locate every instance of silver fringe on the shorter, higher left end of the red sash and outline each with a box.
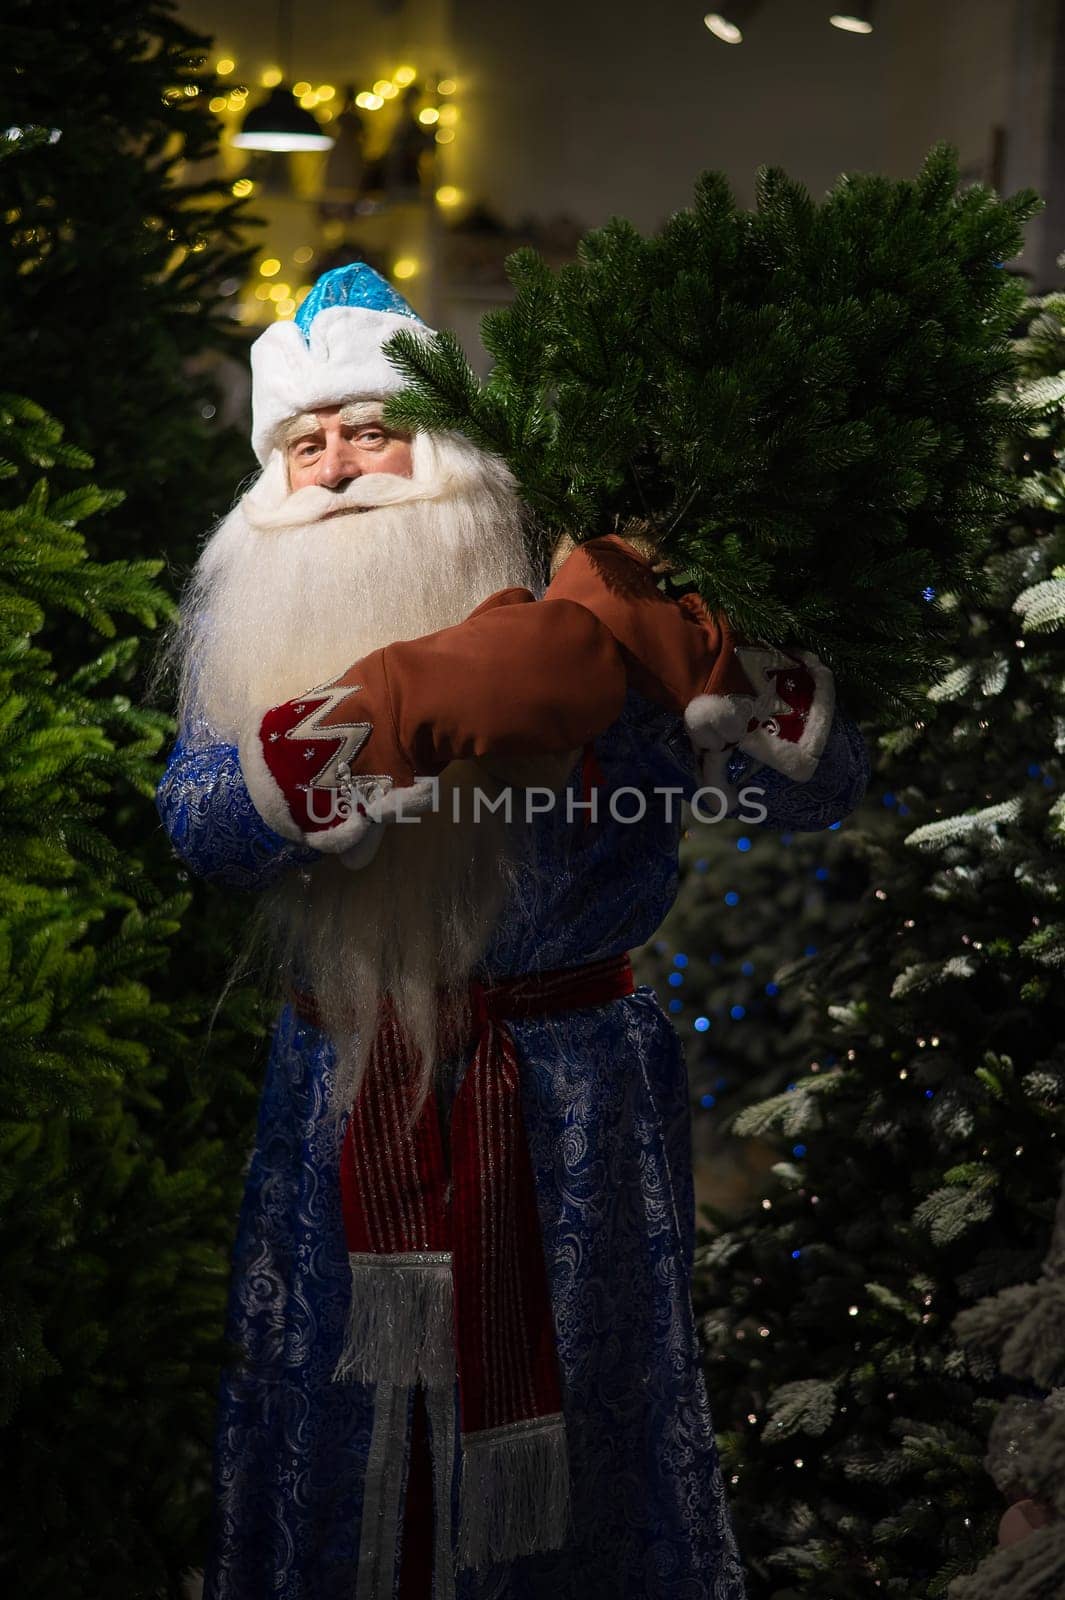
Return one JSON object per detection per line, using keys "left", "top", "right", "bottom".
{"left": 333, "top": 1250, "right": 456, "bottom": 1389}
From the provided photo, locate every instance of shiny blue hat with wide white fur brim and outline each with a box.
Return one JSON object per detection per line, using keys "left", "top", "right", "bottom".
{"left": 251, "top": 261, "right": 432, "bottom": 466}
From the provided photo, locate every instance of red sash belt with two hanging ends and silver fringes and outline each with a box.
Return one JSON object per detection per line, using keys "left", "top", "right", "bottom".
{"left": 287, "top": 954, "right": 633, "bottom": 1566}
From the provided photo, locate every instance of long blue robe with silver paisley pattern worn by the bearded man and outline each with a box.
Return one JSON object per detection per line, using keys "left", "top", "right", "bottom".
{"left": 158, "top": 696, "right": 868, "bottom": 1600}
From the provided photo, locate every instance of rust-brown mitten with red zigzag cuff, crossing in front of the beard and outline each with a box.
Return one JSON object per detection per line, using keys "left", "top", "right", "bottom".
{"left": 240, "top": 589, "right": 625, "bottom": 866}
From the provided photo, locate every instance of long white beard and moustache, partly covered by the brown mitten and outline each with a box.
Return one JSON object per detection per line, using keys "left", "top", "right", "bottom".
{"left": 171, "top": 434, "right": 537, "bottom": 1115}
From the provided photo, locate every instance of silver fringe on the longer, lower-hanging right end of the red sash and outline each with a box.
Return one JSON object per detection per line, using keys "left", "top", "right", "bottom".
{"left": 459, "top": 1413, "right": 569, "bottom": 1566}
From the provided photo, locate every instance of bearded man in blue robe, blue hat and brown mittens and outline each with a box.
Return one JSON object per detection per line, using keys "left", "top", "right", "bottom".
{"left": 158, "top": 266, "right": 868, "bottom": 1600}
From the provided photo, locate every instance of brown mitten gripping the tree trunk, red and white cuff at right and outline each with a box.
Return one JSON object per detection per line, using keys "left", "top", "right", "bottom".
{"left": 545, "top": 534, "right": 835, "bottom": 794}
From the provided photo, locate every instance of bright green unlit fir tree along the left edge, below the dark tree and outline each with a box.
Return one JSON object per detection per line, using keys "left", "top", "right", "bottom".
{"left": 0, "top": 395, "right": 249, "bottom": 1600}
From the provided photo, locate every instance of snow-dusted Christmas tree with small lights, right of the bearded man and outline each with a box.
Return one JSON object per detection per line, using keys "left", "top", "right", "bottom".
{"left": 687, "top": 296, "right": 1065, "bottom": 1600}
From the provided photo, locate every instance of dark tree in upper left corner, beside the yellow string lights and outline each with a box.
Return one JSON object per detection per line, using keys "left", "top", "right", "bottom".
{"left": 0, "top": 0, "right": 254, "bottom": 569}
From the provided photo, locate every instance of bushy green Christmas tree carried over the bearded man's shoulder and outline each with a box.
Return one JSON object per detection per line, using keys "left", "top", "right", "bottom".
{"left": 378, "top": 146, "right": 1039, "bottom": 715}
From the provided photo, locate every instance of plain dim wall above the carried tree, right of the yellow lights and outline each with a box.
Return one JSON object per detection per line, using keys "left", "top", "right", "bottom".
{"left": 453, "top": 0, "right": 884, "bottom": 227}
